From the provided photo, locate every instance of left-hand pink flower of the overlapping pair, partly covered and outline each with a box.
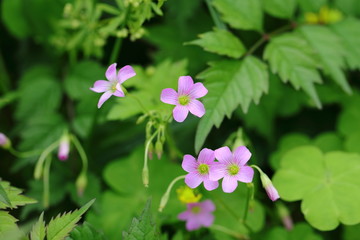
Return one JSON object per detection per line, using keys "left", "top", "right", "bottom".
{"left": 181, "top": 148, "right": 219, "bottom": 191}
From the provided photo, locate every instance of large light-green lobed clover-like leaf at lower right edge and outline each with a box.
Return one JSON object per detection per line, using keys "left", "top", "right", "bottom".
{"left": 273, "top": 146, "right": 360, "bottom": 231}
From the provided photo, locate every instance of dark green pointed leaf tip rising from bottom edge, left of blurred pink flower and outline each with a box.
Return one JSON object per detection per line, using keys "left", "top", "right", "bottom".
{"left": 123, "top": 199, "right": 160, "bottom": 240}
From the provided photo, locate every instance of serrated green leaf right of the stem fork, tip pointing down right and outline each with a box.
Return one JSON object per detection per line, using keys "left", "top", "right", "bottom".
{"left": 264, "top": 33, "right": 322, "bottom": 108}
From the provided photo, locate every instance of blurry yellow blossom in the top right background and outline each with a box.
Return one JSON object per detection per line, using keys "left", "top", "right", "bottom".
{"left": 305, "top": 6, "right": 343, "bottom": 24}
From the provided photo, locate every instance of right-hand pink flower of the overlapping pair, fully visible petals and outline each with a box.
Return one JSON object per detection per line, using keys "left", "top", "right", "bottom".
{"left": 209, "top": 146, "right": 254, "bottom": 193}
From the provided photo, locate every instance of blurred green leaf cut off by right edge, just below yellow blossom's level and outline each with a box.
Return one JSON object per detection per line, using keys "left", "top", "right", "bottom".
{"left": 331, "top": 18, "right": 360, "bottom": 69}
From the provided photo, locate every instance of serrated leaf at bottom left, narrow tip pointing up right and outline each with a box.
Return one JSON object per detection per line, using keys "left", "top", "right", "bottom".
{"left": 46, "top": 199, "right": 95, "bottom": 240}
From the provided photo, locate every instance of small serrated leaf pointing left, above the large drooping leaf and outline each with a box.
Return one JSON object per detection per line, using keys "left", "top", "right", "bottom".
{"left": 187, "top": 28, "right": 246, "bottom": 58}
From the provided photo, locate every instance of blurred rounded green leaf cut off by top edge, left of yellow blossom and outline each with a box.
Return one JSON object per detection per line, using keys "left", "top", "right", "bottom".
{"left": 263, "top": 0, "right": 297, "bottom": 18}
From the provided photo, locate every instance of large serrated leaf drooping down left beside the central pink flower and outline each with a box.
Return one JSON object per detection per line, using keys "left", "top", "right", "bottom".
{"left": 195, "top": 56, "right": 269, "bottom": 152}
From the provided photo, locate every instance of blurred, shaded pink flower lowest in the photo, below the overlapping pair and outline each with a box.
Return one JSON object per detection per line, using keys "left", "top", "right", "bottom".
{"left": 178, "top": 200, "right": 215, "bottom": 231}
